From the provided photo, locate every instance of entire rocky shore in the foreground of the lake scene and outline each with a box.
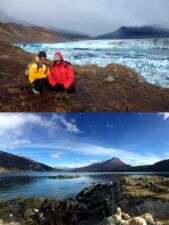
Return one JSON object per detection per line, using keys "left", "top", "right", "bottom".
{"left": 0, "top": 176, "right": 169, "bottom": 225}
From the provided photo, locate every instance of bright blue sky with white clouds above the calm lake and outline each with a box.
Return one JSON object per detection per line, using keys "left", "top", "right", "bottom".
{"left": 0, "top": 113, "right": 169, "bottom": 167}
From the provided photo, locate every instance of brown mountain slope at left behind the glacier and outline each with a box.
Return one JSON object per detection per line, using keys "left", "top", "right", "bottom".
{"left": 0, "top": 21, "right": 89, "bottom": 44}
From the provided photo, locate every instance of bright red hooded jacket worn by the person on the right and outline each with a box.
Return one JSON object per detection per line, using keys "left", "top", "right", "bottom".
{"left": 48, "top": 52, "right": 75, "bottom": 89}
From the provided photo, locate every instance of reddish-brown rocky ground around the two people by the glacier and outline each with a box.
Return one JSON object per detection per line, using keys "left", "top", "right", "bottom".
{"left": 0, "top": 41, "right": 169, "bottom": 112}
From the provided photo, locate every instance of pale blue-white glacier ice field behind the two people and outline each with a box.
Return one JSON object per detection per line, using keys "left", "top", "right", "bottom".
{"left": 18, "top": 39, "right": 169, "bottom": 88}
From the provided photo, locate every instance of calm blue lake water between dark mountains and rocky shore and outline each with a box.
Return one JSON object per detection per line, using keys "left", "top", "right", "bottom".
{"left": 0, "top": 172, "right": 169, "bottom": 201}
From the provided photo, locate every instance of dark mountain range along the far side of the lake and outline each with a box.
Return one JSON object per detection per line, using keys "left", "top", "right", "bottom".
{"left": 0, "top": 151, "right": 169, "bottom": 173}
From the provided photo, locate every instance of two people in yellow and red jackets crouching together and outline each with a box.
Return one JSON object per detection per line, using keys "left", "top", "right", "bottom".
{"left": 28, "top": 52, "right": 75, "bottom": 97}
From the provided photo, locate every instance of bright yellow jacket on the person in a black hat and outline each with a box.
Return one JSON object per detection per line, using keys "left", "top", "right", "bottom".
{"left": 28, "top": 62, "right": 50, "bottom": 84}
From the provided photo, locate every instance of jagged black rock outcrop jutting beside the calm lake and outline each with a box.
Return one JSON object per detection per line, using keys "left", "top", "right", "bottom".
{"left": 33, "top": 182, "right": 122, "bottom": 225}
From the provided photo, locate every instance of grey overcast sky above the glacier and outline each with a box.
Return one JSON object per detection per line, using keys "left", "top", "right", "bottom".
{"left": 0, "top": 0, "right": 169, "bottom": 35}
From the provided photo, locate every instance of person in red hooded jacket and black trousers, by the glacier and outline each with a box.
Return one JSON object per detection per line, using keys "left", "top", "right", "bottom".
{"left": 48, "top": 52, "right": 75, "bottom": 98}
